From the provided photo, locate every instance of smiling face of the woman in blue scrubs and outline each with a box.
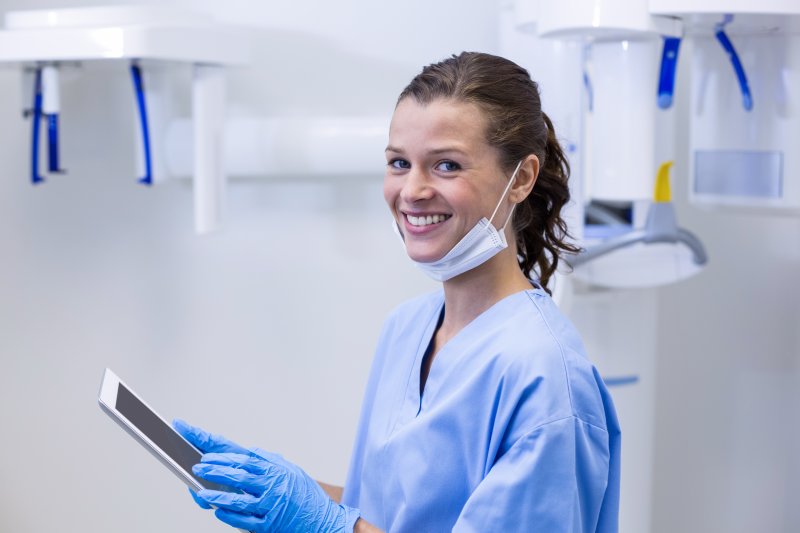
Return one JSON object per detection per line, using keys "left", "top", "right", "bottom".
{"left": 383, "top": 97, "right": 511, "bottom": 262}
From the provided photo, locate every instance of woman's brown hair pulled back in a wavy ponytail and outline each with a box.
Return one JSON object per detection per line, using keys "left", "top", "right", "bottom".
{"left": 397, "top": 52, "right": 579, "bottom": 292}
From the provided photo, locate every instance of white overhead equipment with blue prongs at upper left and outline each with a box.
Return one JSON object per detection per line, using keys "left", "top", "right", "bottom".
{"left": 0, "top": 6, "right": 250, "bottom": 233}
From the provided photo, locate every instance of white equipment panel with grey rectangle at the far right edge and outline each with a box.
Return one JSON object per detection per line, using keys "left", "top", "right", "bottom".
{"left": 690, "top": 32, "right": 800, "bottom": 212}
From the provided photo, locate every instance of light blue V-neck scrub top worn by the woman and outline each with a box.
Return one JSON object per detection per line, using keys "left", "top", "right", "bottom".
{"left": 343, "top": 289, "right": 620, "bottom": 533}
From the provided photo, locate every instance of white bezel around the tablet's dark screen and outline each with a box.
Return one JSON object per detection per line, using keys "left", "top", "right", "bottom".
{"left": 97, "top": 368, "right": 205, "bottom": 491}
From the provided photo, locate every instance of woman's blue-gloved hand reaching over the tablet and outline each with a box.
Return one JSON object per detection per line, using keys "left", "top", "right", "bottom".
{"left": 174, "top": 421, "right": 360, "bottom": 533}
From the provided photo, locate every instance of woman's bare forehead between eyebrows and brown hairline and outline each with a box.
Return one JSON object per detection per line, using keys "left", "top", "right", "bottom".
{"left": 389, "top": 97, "right": 487, "bottom": 149}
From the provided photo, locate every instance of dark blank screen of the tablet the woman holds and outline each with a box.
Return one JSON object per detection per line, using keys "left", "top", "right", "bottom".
{"left": 116, "top": 383, "right": 232, "bottom": 492}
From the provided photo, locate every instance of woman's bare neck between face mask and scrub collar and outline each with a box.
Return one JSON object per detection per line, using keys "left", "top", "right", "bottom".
{"left": 440, "top": 246, "right": 531, "bottom": 338}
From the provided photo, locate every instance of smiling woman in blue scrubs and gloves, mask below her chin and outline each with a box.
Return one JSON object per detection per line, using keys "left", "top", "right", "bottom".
{"left": 176, "top": 53, "right": 620, "bottom": 532}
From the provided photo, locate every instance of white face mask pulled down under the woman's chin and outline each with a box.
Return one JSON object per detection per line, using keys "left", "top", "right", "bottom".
{"left": 392, "top": 161, "right": 522, "bottom": 281}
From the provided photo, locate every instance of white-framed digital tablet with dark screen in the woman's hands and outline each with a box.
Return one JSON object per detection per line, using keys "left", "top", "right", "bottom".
{"left": 97, "top": 368, "right": 233, "bottom": 492}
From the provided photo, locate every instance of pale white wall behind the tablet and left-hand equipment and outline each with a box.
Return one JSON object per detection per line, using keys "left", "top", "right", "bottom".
{"left": 0, "top": 0, "right": 497, "bottom": 533}
